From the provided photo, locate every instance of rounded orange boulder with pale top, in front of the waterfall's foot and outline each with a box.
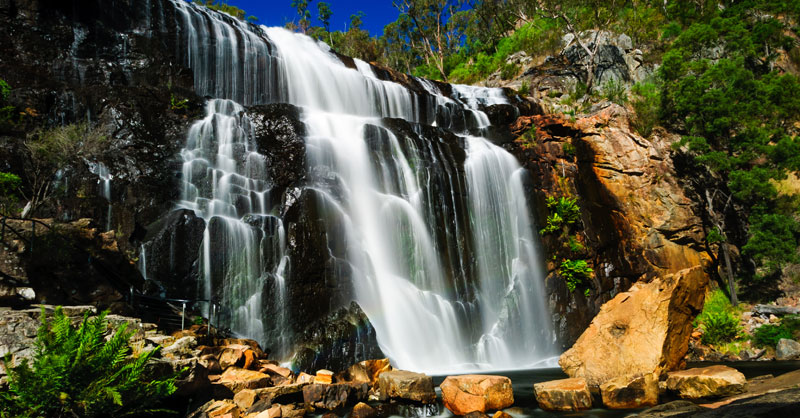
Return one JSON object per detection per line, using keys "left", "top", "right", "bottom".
{"left": 439, "top": 374, "right": 514, "bottom": 415}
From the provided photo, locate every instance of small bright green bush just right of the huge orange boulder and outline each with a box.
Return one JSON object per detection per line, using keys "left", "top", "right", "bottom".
{"left": 695, "top": 289, "right": 741, "bottom": 345}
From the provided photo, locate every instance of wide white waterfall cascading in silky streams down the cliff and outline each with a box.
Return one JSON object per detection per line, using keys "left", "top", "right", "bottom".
{"left": 167, "top": 1, "right": 556, "bottom": 372}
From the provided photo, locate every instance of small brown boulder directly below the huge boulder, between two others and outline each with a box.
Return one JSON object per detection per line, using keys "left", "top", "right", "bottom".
{"left": 600, "top": 373, "right": 659, "bottom": 409}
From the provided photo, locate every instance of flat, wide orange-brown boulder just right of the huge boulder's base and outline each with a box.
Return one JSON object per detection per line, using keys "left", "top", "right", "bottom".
{"left": 667, "top": 365, "right": 747, "bottom": 399}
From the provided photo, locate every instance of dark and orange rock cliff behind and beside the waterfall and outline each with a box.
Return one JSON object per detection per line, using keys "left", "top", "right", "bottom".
{"left": 0, "top": 0, "right": 706, "bottom": 368}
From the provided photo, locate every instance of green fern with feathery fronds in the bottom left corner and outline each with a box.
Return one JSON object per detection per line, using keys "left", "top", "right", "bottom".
{"left": 0, "top": 308, "right": 175, "bottom": 417}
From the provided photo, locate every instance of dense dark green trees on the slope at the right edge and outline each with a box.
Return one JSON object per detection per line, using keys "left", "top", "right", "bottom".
{"left": 659, "top": 0, "right": 800, "bottom": 279}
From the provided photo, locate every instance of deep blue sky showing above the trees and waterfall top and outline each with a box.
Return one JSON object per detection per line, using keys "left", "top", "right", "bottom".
{"left": 200, "top": 0, "right": 398, "bottom": 35}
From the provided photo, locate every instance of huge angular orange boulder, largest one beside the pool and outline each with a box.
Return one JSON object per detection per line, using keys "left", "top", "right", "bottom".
{"left": 558, "top": 266, "right": 708, "bottom": 386}
